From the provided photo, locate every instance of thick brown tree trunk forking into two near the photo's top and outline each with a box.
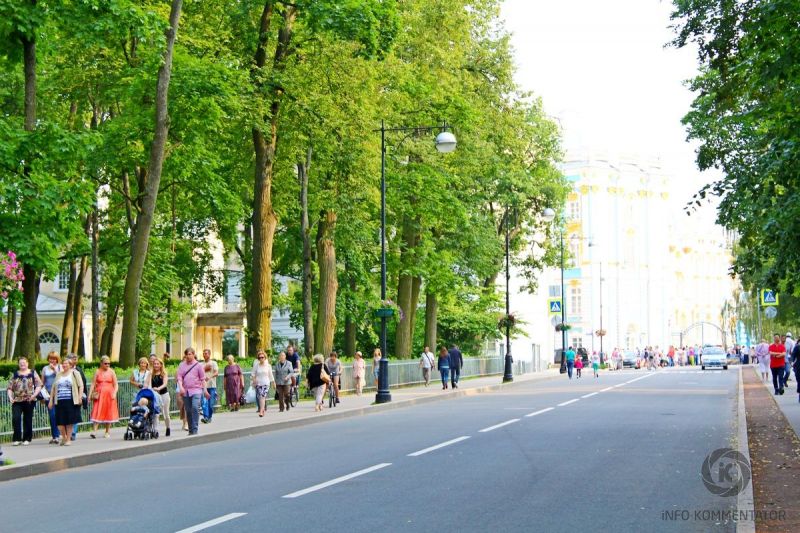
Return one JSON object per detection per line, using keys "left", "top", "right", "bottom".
{"left": 247, "top": 2, "right": 297, "bottom": 352}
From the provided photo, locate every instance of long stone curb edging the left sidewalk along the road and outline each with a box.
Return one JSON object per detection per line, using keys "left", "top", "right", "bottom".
{"left": 0, "top": 374, "right": 559, "bottom": 483}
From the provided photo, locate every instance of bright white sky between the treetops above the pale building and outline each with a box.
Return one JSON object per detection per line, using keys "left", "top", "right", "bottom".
{"left": 502, "top": 0, "right": 710, "bottom": 203}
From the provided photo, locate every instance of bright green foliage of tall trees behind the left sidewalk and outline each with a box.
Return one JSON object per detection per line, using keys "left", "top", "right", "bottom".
{"left": 0, "top": 0, "right": 567, "bottom": 362}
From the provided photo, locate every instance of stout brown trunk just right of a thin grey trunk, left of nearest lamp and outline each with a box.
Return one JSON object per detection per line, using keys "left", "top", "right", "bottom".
{"left": 314, "top": 210, "right": 339, "bottom": 356}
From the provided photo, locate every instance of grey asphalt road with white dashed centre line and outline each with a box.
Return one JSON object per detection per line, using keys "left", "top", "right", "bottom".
{"left": 0, "top": 369, "right": 737, "bottom": 533}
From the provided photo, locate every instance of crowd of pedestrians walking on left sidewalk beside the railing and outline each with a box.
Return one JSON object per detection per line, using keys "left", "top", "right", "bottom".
{"left": 7, "top": 345, "right": 464, "bottom": 446}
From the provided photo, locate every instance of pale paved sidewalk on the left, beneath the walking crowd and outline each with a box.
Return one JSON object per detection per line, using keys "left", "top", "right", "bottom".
{"left": 0, "top": 368, "right": 559, "bottom": 482}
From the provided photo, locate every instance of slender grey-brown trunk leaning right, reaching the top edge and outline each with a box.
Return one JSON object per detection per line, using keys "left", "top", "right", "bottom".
{"left": 119, "top": 0, "right": 183, "bottom": 367}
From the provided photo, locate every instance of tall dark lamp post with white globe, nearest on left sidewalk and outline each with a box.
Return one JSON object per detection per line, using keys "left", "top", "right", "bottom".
{"left": 375, "top": 120, "right": 456, "bottom": 403}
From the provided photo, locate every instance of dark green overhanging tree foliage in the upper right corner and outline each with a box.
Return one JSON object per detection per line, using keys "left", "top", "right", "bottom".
{"left": 673, "top": 0, "right": 800, "bottom": 304}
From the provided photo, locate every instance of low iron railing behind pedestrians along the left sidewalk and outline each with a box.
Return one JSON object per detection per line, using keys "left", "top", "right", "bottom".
{"left": 0, "top": 357, "right": 540, "bottom": 442}
